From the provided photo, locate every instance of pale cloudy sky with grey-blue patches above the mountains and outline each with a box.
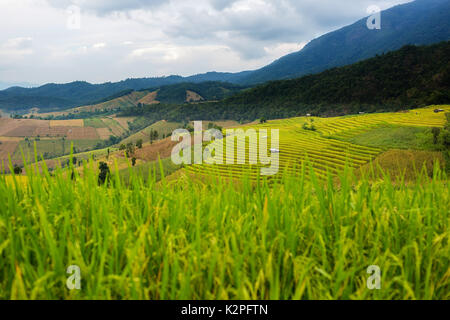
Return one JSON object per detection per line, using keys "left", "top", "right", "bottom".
{"left": 0, "top": 0, "right": 410, "bottom": 84}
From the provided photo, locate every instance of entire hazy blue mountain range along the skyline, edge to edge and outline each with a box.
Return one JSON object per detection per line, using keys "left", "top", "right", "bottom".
{"left": 0, "top": 0, "right": 450, "bottom": 111}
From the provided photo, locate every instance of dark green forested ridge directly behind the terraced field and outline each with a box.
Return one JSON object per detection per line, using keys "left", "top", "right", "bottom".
{"left": 118, "top": 42, "right": 450, "bottom": 122}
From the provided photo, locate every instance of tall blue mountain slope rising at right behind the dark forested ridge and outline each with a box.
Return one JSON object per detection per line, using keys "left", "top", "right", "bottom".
{"left": 239, "top": 0, "right": 450, "bottom": 84}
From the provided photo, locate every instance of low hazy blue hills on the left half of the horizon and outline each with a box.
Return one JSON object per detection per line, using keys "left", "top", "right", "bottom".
{"left": 0, "top": 77, "right": 244, "bottom": 113}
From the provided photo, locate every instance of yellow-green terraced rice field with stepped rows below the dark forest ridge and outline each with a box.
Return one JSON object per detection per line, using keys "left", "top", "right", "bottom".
{"left": 186, "top": 106, "right": 450, "bottom": 180}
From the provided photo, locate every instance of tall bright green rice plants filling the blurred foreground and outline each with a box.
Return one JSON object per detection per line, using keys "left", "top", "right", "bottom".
{"left": 0, "top": 157, "right": 450, "bottom": 300}
